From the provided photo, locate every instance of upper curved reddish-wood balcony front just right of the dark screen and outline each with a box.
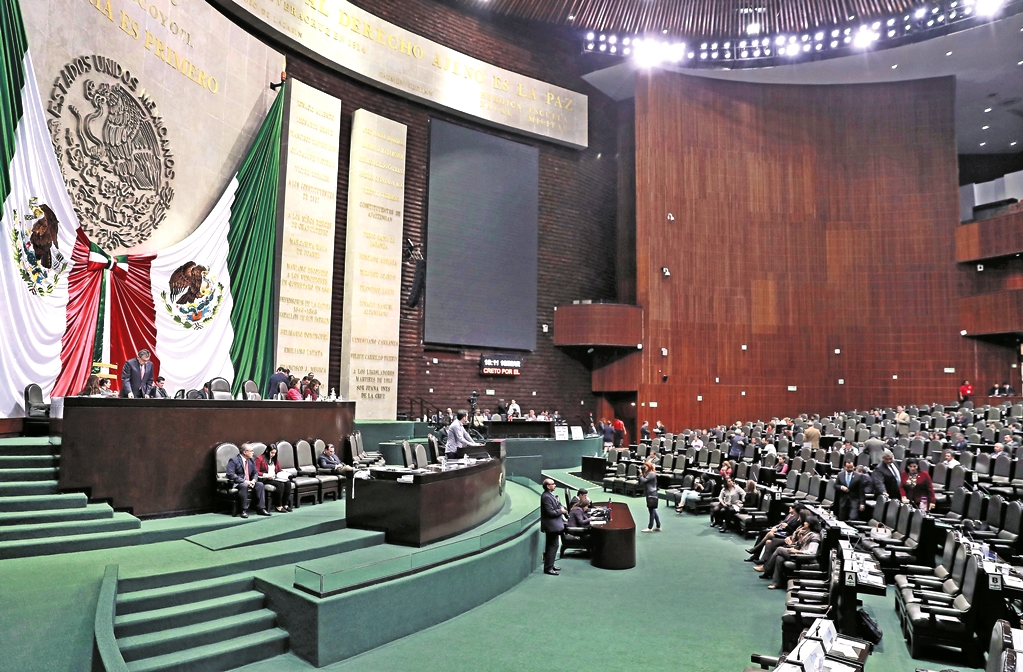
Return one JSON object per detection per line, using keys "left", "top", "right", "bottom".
{"left": 553, "top": 304, "right": 642, "bottom": 346}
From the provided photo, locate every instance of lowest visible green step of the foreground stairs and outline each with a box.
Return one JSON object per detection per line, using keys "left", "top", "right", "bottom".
{"left": 128, "top": 628, "right": 287, "bottom": 672}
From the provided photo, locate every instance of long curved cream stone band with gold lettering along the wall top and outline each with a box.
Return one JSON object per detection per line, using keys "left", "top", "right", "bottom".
{"left": 213, "top": 0, "right": 587, "bottom": 148}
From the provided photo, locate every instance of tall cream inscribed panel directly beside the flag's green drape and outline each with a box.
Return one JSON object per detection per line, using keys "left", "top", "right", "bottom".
{"left": 277, "top": 80, "right": 341, "bottom": 393}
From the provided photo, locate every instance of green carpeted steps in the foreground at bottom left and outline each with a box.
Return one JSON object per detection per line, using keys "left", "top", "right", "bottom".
{"left": 114, "top": 573, "right": 287, "bottom": 672}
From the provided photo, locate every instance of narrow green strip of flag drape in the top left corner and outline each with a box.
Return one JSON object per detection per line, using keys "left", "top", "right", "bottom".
{"left": 0, "top": 0, "right": 29, "bottom": 204}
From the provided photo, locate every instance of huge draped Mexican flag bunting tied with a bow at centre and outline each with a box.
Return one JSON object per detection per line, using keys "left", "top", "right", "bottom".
{"left": 0, "top": 0, "right": 284, "bottom": 417}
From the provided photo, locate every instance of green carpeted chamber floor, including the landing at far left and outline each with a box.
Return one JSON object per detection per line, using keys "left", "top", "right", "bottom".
{"left": 0, "top": 466, "right": 990, "bottom": 672}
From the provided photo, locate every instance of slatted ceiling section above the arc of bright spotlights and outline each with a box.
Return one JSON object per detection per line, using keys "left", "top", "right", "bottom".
{"left": 456, "top": 0, "right": 920, "bottom": 38}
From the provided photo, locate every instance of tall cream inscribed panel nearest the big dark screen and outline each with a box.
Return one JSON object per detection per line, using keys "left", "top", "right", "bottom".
{"left": 341, "top": 109, "right": 406, "bottom": 419}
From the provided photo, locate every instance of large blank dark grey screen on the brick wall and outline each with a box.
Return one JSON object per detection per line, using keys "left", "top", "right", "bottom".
{"left": 424, "top": 120, "right": 539, "bottom": 350}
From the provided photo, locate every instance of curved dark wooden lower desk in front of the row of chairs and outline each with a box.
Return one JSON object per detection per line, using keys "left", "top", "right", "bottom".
{"left": 345, "top": 458, "right": 504, "bottom": 546}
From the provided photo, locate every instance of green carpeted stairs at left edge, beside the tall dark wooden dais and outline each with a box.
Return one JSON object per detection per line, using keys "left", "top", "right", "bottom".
{"left": 0, "top": 437, "right": 141, "bottom": 559}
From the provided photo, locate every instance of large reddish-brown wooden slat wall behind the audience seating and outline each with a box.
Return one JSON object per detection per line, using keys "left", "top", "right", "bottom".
{"left": 636, "top": 72, "right": 1015, "bottom": 430}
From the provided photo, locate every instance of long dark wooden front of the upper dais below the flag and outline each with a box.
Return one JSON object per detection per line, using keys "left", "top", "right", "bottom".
{"left": 59, "top": 397, "right": 355, "bottom": 517}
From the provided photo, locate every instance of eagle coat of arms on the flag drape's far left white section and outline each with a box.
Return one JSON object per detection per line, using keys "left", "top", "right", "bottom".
{"left": 10, "top": 198, "right": 68, "bottom": 297}
